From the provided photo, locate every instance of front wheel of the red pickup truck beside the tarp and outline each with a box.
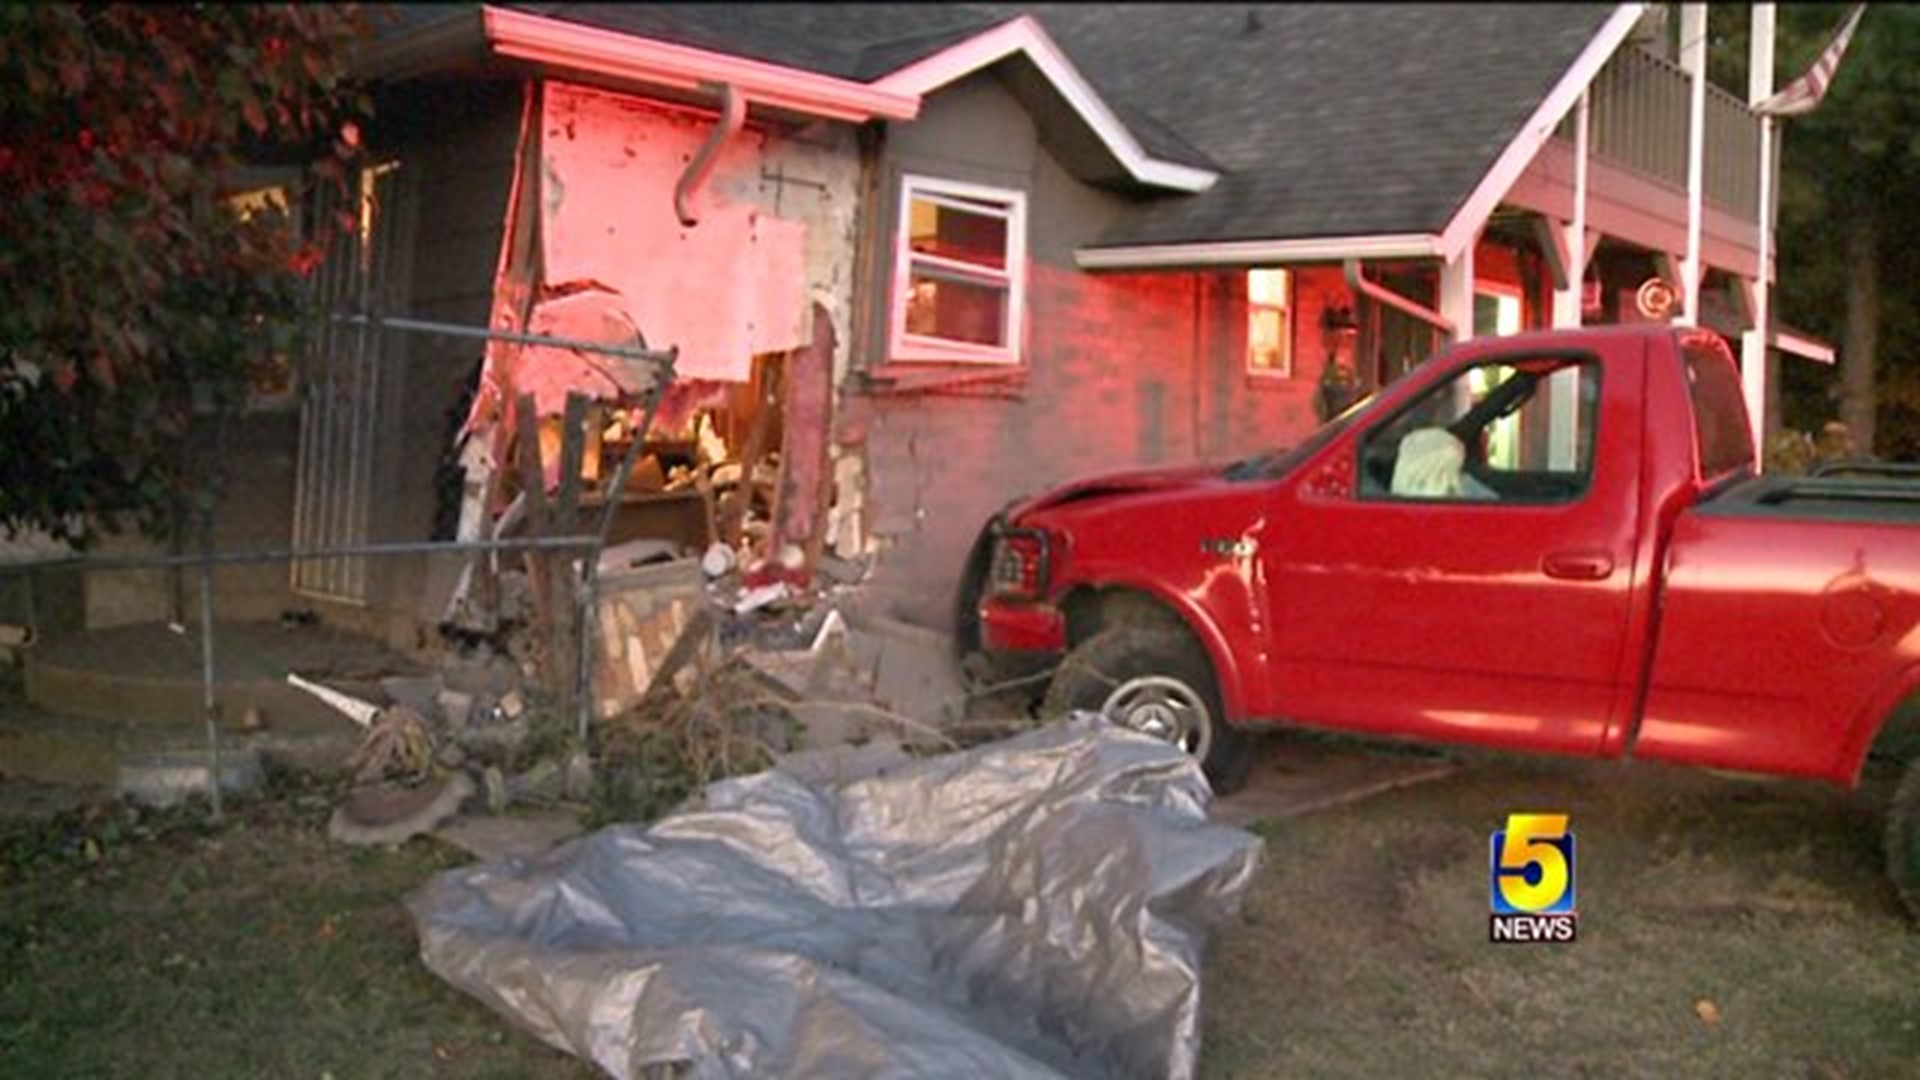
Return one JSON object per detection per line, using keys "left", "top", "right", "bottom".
{"left": 1041, "top": 626, "right": 1254, "bottom": 796}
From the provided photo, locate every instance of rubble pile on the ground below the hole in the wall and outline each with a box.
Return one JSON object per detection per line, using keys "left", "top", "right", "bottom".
{"left": 288, "top": 530, "right": 996, "bottom": 844}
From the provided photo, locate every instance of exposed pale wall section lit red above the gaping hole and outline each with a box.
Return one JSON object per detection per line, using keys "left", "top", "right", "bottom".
{"left": 422, "top": 83, "right": 875, "bottom": 634}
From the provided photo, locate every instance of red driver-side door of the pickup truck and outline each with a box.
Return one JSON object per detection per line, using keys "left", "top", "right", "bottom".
{"left": 1263, "top": 343, "right": 1640, "bottom": 753}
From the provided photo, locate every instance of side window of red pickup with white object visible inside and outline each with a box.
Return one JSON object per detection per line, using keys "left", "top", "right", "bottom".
{"left": 1359, "top": 356, "right": 1599, "bottom": 503}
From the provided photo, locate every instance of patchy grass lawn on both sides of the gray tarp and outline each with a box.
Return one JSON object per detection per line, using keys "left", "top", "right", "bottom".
{"left": 0, "top": 737, "right": 1920, "bottom": 1080}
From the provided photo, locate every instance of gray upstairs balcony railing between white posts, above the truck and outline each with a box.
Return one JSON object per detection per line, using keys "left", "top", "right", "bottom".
{"left": 1553, "top": 46, "right": 1761, "bottom": 221}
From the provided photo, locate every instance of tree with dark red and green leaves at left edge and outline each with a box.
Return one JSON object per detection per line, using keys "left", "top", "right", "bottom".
{"left": 0, "top": 4, "right": 371, "bottom": 544}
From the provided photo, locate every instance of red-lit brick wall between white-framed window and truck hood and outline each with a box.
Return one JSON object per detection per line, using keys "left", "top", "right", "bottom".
{"left": 856, "top": 239, "right": 1338, "bottom": 628}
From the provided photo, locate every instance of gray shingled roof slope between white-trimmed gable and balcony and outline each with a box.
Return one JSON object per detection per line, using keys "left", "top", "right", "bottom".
{"left": 1002, "top": 4, "right": 1617, "bottom": 246}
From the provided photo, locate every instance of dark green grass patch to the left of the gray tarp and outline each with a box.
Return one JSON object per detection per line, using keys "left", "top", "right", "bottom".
{"left": 0, "top": 780, "right": 597, "bottom": 1080}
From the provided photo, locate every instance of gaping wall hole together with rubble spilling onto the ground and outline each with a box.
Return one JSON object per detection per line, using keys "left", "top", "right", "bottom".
{"left": 291, "top": 292, "right": 1013, "bottom": 836}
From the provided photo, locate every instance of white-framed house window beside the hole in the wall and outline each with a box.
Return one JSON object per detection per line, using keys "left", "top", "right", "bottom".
{"left": 893, "top": 177, "right": 1027, "bottom": 363}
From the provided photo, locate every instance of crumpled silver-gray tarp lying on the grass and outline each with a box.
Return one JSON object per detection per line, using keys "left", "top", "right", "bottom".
{"left": 409, "top": 715, "right": 1261, "bottom": 1078}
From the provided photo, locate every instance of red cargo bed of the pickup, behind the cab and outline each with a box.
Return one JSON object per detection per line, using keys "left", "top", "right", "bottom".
{"left": 1636, "top": 467, "right": 1920, "bottom": 784}
